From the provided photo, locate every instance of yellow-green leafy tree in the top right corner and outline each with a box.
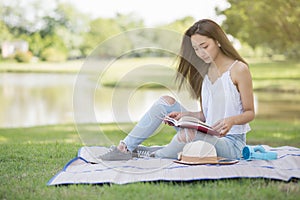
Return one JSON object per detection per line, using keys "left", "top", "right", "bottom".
{"left": 217, "top": 0, "right": 300, "bottom": 58}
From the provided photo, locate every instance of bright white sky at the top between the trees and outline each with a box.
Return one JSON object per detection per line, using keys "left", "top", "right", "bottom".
{"left": 60, "top": 0, "right": 229, "bottom": 26}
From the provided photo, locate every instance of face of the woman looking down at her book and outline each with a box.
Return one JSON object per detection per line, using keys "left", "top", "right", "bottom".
{"left": 191, "top": 34, "right": 219, "bottom": 63}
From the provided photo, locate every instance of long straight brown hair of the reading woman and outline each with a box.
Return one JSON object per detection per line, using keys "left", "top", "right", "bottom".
{"left": 176, "top": 19, "right": 248, "bottom": 100}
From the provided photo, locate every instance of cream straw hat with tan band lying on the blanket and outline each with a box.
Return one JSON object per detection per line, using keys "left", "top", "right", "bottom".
{"left": 174, "top": 140, "right": 238, "bottom": 165}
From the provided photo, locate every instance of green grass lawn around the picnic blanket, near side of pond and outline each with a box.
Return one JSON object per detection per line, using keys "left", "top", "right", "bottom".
{"left": 0, "top": 119, "right": 300, "bottom": 199}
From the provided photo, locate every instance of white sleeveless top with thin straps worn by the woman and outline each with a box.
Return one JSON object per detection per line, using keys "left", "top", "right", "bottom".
{"left": 201, "top": 60, "right": 251, "bottom": 134}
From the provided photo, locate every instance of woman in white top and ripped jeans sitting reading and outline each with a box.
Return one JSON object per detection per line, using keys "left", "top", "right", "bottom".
{"left": 100, "top": 19, "right": 255, "bottom": 160}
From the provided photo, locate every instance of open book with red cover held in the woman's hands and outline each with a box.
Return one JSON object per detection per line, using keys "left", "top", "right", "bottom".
{"left": 163, "top": 116, "right": 220, "bottom": 136}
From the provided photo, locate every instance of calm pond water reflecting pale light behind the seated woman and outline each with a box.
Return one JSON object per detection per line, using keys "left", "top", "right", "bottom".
{"left": 0, "top": 73, "right": 300, "bottom": 127}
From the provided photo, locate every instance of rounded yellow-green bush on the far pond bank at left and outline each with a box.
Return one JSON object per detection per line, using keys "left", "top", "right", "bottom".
{"left": 41, "top": 47, "right": 67, "bottom": 62}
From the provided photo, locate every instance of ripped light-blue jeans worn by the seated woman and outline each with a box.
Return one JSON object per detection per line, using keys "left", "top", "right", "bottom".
{"left": 122, "top": 96, "right": 246, "bottom": 159}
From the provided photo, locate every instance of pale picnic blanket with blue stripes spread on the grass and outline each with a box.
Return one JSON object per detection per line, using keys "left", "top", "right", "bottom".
{"left": 48, "top": 145, "right": 300, "bottom": 185}
